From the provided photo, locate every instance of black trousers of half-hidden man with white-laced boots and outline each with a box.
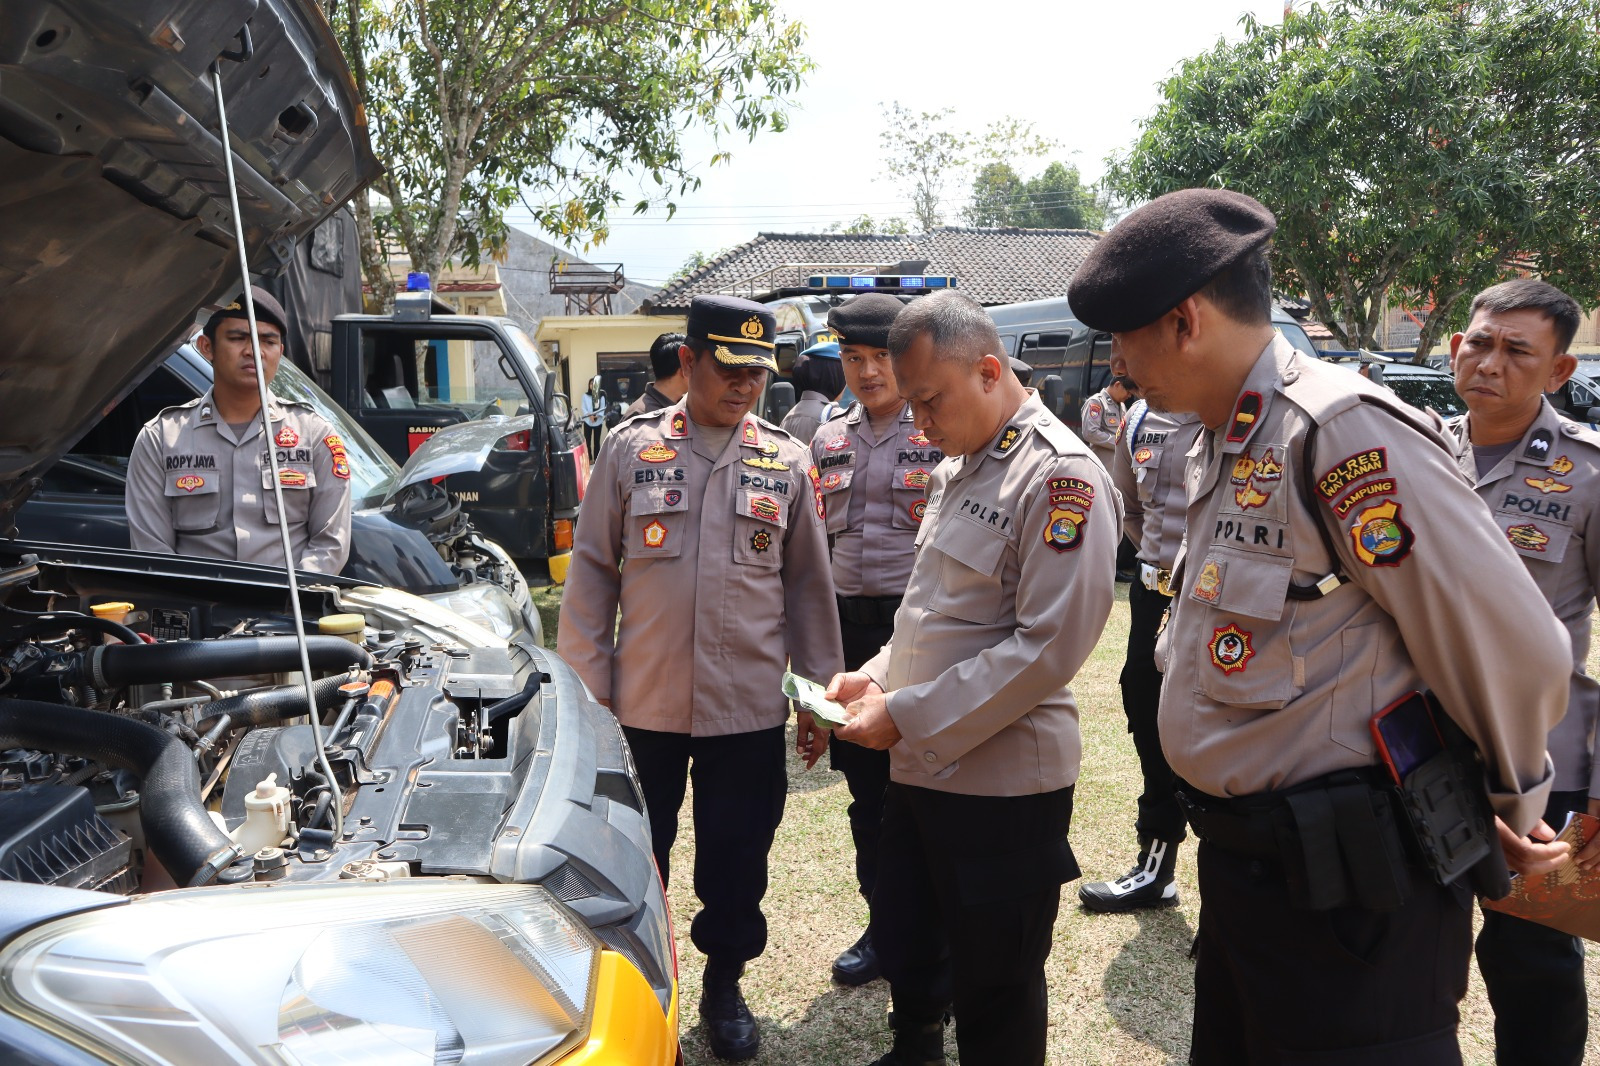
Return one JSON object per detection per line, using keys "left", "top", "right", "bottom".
{"left": 1120, "top": 579, "right": 1187, "bottom": 840}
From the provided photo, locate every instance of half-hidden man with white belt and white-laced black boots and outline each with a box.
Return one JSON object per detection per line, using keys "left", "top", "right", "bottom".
{"left": 1078, "top": 393, "right": 1202, "bottom": 912}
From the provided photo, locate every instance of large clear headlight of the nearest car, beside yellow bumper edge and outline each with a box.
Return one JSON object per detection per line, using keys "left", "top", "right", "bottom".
{"left": 0, "top": 880, "right": 600, "bottom": 1066}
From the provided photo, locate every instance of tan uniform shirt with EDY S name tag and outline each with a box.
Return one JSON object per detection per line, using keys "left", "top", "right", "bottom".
{"left": 557, "top": 393, "right": 843, "bottom": 736}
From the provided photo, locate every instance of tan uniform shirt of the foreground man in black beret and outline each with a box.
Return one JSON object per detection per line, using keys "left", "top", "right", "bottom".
{"left": 1158, "top": 336, "right": 1570, "bottom": 832}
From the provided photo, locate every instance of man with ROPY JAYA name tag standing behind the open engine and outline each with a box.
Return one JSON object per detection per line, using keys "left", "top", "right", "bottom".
{"left": 126, "top": 288, "right": 350, "bottom": 573}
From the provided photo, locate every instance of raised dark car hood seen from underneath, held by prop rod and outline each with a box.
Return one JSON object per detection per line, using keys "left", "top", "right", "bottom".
{"left": 0, "top": 0, "right": 378, "bottom": 536}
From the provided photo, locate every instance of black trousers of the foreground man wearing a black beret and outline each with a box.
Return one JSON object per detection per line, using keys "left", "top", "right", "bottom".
{"left": 1189, "top": 840, "right": 1472, "bottom": 1066}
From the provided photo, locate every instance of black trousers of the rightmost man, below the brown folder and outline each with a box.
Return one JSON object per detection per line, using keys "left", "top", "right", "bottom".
{"left": 1478, "top": 791, "right": 1589, "bottom": 1066}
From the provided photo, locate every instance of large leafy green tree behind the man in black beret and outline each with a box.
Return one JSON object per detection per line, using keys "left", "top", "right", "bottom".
{"left": 1110, "top": 0, "right": 1600, "bottom": 357}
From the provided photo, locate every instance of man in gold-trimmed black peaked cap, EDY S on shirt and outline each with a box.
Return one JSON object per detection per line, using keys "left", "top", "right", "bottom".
{"left": 557, "top": 296, "right": 840, "bottom": 1060}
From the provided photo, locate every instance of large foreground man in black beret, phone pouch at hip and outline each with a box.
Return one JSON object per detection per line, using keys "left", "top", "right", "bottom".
{"left": 1069, "top": 189, "right": 1571, "bottom": 1066}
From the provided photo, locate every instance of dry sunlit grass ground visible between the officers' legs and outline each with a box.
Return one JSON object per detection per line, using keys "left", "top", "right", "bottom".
{"left": 534, "top": 586, "right": 1600, "bottom": 1066}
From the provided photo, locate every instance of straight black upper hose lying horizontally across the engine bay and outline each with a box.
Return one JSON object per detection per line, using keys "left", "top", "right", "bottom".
{"left": 75, "top": 635, "right": 373, "bottom": 688}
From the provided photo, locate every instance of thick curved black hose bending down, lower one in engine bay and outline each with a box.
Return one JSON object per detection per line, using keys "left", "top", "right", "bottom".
{"left": 0, "top": 699, "right": 238, "bottom": 885}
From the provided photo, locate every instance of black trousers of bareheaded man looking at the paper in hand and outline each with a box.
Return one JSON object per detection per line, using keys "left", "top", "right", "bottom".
{"left": 872, "top": 781, "right": 1078, "bottom": 1066}
